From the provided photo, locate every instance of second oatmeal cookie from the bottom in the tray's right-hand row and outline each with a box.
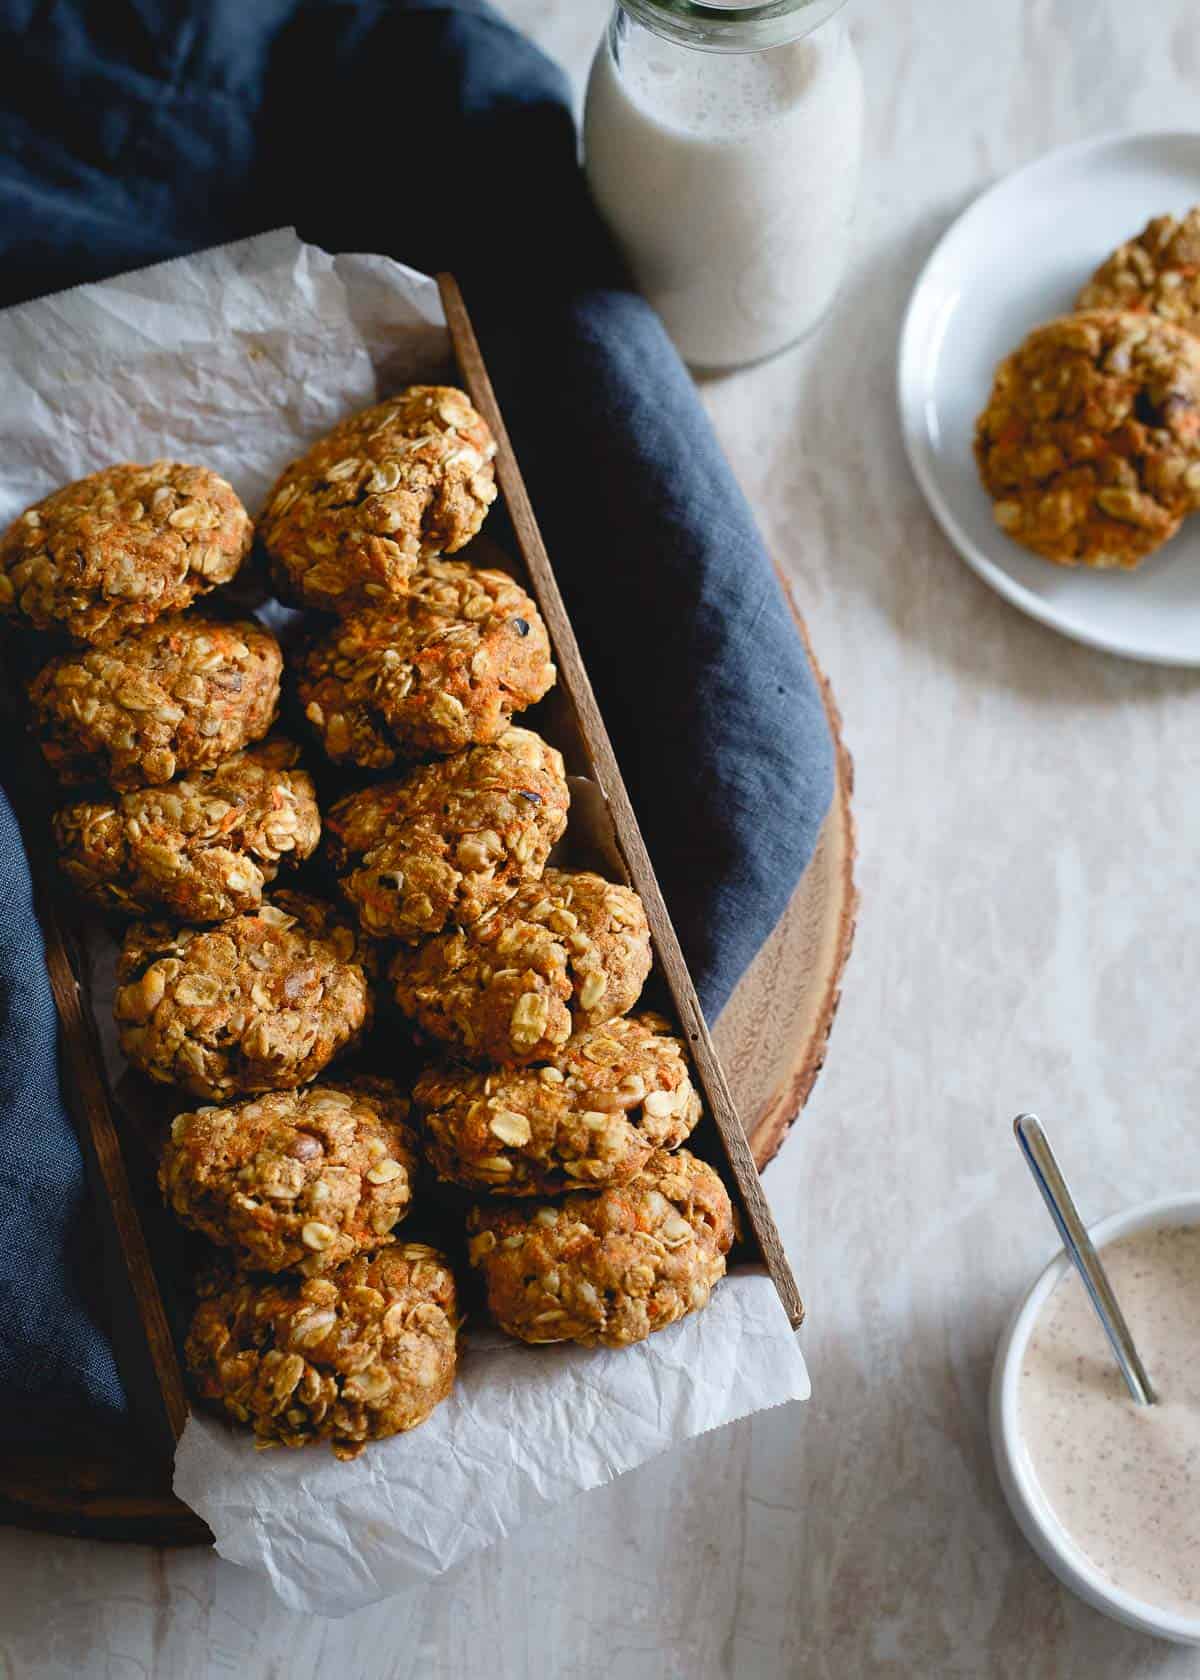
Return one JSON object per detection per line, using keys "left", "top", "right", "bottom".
{"left": 412, "top": 1013, "right": 701, "bottom": 1196}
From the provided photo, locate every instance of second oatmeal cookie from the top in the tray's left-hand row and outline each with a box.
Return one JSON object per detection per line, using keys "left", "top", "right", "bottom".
{"left": 29, "top": 613, "right": 284, "bottom": 790}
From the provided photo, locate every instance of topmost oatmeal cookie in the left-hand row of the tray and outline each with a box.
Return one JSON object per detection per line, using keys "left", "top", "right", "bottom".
{"left": 0, "top": 460, "right": 254, "bottom": 647}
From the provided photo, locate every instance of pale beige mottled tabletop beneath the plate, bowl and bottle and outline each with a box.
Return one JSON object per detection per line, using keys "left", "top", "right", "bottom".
{"left": 0, "top": 0, "right": 1200, "bottom": 1680}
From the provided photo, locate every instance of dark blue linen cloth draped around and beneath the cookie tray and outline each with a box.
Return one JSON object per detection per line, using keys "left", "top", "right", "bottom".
{"left": 0, "top": 0, "right": 834, "bottom": 1440}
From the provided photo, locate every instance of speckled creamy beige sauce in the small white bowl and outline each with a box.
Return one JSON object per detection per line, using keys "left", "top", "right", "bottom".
{"left": 1018, "top": 1226, "right": 1200, "bottom": 1616}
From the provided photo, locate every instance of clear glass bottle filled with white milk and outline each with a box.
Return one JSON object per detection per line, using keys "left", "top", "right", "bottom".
{"left": 583, "top": 0, "right": 862, "bottom": 370}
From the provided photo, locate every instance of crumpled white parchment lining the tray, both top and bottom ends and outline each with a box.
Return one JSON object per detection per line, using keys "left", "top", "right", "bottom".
{"left": 0, "top": 230, "right": 808, "bottom": 1616}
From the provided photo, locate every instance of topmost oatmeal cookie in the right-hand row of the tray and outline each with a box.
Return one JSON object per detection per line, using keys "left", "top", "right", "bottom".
{"left": 259, "top": 385, "right": 496, "bottom": 613}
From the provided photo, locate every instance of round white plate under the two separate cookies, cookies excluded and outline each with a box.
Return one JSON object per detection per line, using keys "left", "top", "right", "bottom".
{"left": 899, "top": 133, "right": 1200, "bottom": 665}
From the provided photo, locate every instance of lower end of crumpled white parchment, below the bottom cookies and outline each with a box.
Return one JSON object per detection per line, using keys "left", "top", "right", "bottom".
{"left": 175, "top": 1268, "right": 808, "bottom": 1616}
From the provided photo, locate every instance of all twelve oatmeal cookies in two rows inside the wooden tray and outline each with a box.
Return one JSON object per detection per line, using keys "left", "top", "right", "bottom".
{"left": 0, "top": 386, "right": 734, "bottom": 1457}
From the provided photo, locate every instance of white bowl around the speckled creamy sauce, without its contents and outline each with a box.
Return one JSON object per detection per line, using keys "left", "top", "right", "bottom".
{"left": 988, "top": 1191, "right": 1200, "bottom": 1645}
